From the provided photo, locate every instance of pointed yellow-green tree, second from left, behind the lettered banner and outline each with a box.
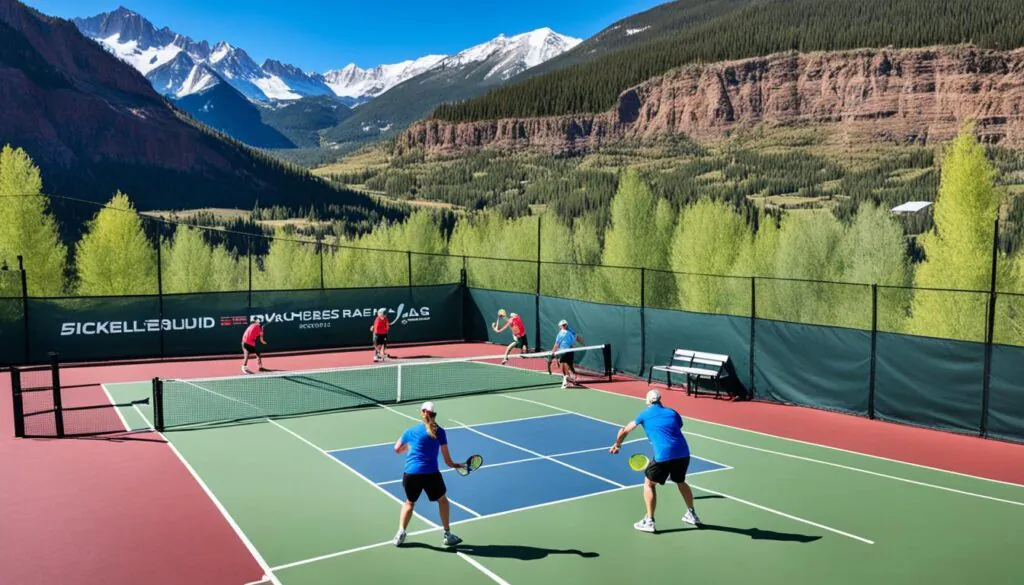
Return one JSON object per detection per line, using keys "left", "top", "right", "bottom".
{"left": 75, "top": 192, "right": 157, "bottom": 296}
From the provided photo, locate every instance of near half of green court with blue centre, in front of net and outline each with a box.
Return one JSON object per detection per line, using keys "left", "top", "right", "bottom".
{"left": 104, "top": 382, "right": 1024, "bottom": 585}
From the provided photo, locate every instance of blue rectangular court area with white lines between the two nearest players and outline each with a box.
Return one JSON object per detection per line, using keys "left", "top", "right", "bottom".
{"left": 329, "top": 413, "right": 731, "bottom": 523}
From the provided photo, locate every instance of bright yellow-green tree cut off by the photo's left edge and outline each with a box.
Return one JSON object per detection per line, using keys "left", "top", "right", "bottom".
{"left": 0, "top": 147, "right": 68, "bottom": 296}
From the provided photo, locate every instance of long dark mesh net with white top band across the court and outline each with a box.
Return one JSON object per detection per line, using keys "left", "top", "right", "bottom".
{"left": 153, "top": 344, "right": 612, "bottom": 430}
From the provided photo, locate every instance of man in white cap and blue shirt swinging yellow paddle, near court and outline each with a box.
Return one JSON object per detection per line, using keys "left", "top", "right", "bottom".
{"left": 609, "top": 388, "right": 700, "bottom": 532}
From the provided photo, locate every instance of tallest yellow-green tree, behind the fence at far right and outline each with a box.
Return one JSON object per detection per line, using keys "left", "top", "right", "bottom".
{"left": 909, "top": 127, "right": 1007, "bottom": 341}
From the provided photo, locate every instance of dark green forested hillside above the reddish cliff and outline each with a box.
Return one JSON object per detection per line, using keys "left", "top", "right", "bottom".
{"left": 433, "top": 0, "right": 1024, "bottom": 121}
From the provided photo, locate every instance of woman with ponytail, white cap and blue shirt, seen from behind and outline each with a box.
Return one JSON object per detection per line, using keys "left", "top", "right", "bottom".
{"left": 394, "top": 403, "right": 463, "bottom": 546}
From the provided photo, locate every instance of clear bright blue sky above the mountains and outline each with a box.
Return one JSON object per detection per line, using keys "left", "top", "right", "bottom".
{"left": 27, "top": 0, "right": 665, "bottom": 72}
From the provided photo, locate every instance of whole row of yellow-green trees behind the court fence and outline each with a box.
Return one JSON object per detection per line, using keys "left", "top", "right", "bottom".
{"left": 0, "top": 130, "right": 1024, "bottom": 344}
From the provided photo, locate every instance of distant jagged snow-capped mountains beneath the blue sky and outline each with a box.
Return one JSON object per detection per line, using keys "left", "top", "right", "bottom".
{"left": 74, "top": 7, "right": 581, "bottom": 149}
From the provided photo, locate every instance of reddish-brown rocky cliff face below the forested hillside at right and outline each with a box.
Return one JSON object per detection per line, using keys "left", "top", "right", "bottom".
{"left": 398, "top": 47, "right": 1024, "bottom": 153}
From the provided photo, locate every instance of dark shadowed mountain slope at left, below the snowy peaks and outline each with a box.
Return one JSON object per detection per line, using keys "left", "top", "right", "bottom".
{"left": 0, "top": 0, "right": 400, "bottom": 225}
